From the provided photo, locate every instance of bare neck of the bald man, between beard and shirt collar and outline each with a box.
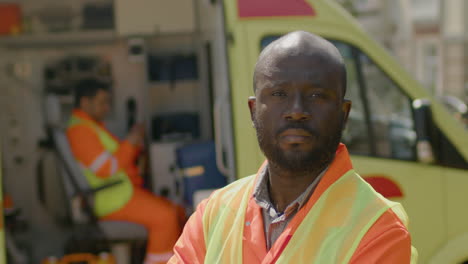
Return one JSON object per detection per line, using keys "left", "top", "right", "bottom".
{"left": 268, "top": 164, "right": 328, "bottom": 212}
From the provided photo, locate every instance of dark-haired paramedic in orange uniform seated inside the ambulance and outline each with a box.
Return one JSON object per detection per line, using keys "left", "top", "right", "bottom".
{"left": 67, "top": 79, "right": 183, "bottom": 264}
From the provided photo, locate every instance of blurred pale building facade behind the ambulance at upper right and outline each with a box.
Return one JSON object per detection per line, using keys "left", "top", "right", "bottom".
{"left": 340, "top": 0, "right": 468, "bottom": 104}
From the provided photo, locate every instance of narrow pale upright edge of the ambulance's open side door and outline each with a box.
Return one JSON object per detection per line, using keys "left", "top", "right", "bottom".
{"left": 196, "top": 1, "right": 236, "bottom": 182}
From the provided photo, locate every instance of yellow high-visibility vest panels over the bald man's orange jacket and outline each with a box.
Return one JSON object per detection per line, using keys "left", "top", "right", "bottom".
{"left": 203, "top": 169, "right": 414, "bottom": 263}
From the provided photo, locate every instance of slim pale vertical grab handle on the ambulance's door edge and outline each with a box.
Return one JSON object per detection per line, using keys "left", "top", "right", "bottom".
{"left": 213, "top": 92, "right": 230, "bottom": 178}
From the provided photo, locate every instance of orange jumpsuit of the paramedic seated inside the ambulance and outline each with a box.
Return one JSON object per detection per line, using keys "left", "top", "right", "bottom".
{"left": 67, "top": 109, "right": 183, "bottom": 264}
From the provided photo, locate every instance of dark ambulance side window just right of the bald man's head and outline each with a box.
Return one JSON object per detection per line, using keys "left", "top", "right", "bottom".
{"left": 332, "top": 41, "right": 416, "bottom": 160}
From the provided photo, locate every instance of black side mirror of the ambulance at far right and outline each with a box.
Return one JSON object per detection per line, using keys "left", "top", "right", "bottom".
{"left": 413, "top": 99, "right": 435, "bottom": 164}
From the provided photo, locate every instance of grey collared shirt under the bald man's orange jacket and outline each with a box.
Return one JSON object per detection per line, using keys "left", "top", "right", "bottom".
{"left": 253, "top": 165, "right": 327, "bottom": 250}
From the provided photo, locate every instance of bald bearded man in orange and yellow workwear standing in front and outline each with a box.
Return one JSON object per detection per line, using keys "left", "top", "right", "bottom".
{"left": 169, "top": 31, "right": 416, "bottom": 264}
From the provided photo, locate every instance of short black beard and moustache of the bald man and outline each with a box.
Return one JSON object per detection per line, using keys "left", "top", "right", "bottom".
{"left": 254, "top": 119, "right": 344, "bottom": 174}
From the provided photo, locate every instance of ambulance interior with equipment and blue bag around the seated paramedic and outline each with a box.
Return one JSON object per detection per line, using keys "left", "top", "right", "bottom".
{"left": 0, "top": 0, "right": 234, "bottom": 263}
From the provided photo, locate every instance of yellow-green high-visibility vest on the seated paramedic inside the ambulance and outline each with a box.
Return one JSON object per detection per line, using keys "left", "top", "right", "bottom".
{"left": 68, "top": 115, "right": 133, "bottom": 217}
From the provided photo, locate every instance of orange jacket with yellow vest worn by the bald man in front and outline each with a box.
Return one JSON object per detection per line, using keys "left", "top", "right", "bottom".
{"left": 169, "top": 145, "right": 417, "bottom": 263}
